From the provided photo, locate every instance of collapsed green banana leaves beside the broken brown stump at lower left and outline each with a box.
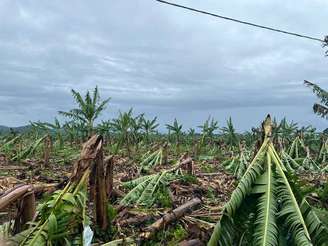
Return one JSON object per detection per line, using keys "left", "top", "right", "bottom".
{"left": 11, "top": 170, "right": 93, "bottom": 246}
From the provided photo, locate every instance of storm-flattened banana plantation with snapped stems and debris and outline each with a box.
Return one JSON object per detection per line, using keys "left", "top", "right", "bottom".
{"left": 0, "top": 85, "right": 328, "bottom": 246}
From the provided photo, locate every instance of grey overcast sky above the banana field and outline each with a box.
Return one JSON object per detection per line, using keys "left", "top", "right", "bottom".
{"left": 0, "top": 0, "right": 328, "bottom": 130}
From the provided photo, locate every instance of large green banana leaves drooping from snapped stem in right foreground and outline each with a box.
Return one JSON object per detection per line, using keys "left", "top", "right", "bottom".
{"left": 208, "top": 131, "right": 328, "bottom": 246}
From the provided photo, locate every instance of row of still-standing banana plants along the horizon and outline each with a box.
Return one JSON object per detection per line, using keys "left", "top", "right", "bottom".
{"left": 0, "top": 81, "right": 328, "bottom": 160}
